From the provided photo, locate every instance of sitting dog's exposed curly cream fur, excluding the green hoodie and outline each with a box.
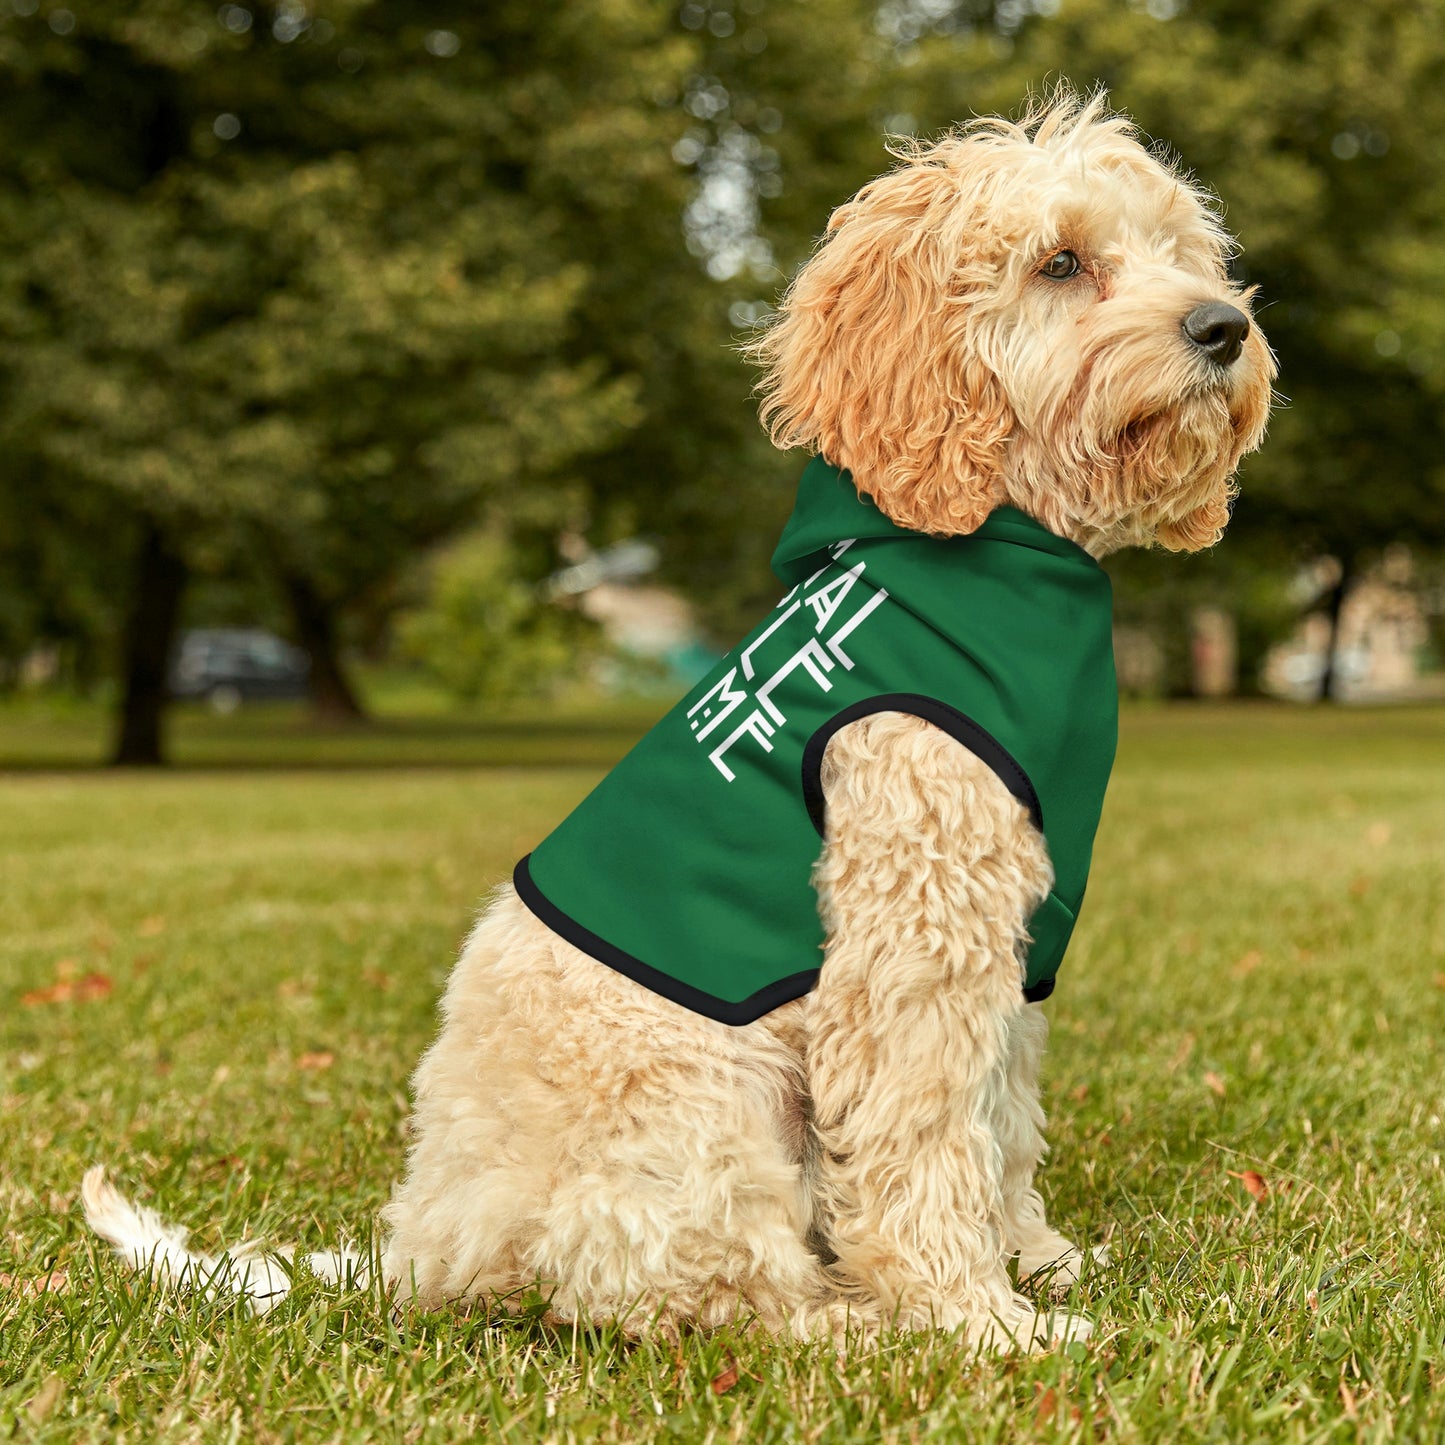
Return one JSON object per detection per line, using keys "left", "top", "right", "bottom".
{"left": 85, "top": 94, "right": 1273, "bottom": 1345}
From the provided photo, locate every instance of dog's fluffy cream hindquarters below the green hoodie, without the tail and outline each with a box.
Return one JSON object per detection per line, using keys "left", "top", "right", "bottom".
{"left": 383, "top": 889, "right": 824, "bottom": 1335}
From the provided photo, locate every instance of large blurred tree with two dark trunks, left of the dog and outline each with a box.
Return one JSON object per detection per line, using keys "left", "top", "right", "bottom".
{"left": 0, "top": 0, "right": 691, "bottom": 762}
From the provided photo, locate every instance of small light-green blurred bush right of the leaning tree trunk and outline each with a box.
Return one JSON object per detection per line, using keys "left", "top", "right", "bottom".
{"left": 397, "top": 530, "right": 597, "bottom": 702}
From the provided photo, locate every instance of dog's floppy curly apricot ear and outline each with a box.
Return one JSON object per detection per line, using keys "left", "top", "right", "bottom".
{"left": 749, "top": 149, "right": 1013, "bottom": 535}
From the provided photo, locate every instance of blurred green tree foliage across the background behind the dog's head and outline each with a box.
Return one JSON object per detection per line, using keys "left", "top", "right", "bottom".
{"left": 0, "top": 0, "right": 1445, "bottom": 702}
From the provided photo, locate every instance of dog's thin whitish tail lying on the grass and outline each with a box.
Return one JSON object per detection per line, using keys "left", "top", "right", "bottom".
{"left": 81, "top": 1165, "right": 370, "bottom": 1315}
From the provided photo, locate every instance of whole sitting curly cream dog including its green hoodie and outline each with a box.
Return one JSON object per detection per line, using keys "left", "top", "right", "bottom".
{"left": 84, "top": 90, "right": 1274, "bottom": 1348}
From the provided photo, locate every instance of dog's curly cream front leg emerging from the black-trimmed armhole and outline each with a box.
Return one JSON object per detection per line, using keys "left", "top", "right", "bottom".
{"left": 808, "top": 714, "right": 1088, "bottom": 1347}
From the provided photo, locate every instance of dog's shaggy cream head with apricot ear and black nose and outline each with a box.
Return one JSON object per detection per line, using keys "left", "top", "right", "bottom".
{"left": 751, "top": 91, "right": 1274, "bottom": 553}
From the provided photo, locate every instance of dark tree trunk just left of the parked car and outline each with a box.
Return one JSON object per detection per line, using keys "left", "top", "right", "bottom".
{"left": 111, "top": 522, "right": 186, "bottom": 767}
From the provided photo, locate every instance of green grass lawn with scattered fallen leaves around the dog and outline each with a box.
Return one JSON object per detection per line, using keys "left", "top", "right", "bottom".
{"left": 0, "top": 707, "right": 1445, "bottom": 1442}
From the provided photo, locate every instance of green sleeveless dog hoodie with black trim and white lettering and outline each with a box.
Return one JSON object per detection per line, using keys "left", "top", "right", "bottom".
{"left": 514, "top": 458, "right": 1118, "bottom": 1025}
